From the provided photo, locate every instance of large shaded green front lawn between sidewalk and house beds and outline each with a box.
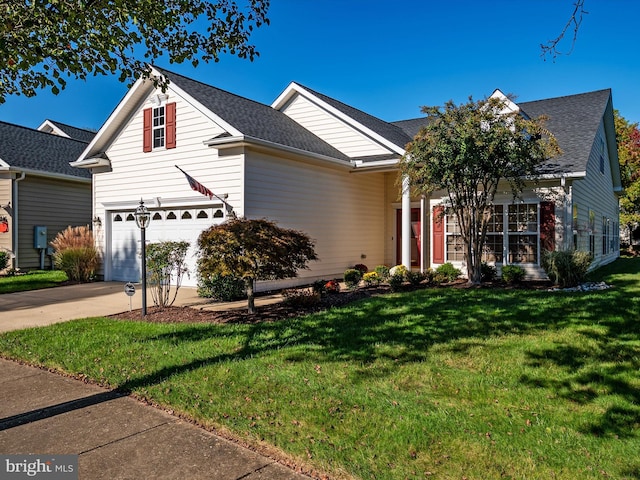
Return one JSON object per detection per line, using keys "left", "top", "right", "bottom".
{"left": 0, "top": 259, "right": 640, "bottom": 480}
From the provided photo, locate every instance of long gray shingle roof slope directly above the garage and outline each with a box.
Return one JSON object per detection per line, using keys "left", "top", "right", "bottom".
{"left": 156, "top": 67, "right": 349, "bottom": 162}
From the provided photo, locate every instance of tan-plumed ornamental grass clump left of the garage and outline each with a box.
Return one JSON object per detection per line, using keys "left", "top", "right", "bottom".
{"left": 51, "top": 226, "right": 100, "bottom": 282}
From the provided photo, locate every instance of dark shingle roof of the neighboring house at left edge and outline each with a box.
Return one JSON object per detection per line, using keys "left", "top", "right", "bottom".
{"left": 0, "top": 122, "right": 91, "bottom": 178}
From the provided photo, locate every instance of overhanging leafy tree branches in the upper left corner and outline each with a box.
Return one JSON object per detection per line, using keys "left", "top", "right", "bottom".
{"left": 0, "top": 0, "right": 269, "bottom": 103}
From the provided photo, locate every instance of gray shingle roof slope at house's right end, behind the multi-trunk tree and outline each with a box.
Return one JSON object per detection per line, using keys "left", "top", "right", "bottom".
{"left": 518, "top": 89, "right": 611, "bottom": 174}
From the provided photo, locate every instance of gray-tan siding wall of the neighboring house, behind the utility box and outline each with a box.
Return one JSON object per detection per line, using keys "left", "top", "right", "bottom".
{"left": 17, "top": 174, "right": 91, "bottom": 270}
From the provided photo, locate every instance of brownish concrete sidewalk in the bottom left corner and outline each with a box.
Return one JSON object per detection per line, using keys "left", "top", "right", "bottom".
{"left": 0, "top": 359, "right": 309, "bottom": 480}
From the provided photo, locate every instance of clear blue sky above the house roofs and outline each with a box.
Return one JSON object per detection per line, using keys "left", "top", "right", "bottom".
{"left": 0, "top": 0, "right": 640, "bottom": 129}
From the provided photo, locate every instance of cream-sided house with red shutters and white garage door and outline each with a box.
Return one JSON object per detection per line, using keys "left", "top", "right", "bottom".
{"left": 72, "top": 69, "right": 620, "bottom": 289}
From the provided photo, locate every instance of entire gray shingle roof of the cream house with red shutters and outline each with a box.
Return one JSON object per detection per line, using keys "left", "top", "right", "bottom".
{"left": 158, "top": 68, "right": 611, "bottom": 178}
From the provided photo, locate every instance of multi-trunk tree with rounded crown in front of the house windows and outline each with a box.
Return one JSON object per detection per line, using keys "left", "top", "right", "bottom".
{"left": 400, "top": 98, "right": 559, "bottom": 283}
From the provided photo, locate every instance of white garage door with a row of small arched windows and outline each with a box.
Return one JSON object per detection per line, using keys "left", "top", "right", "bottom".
{"left": 110, "top": 208, "right": 224, "bottom": 286}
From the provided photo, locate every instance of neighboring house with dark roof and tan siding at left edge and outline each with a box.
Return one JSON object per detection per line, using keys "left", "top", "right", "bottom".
{"left": 0, "top": 122, "right": 95, "bottom": 270}
